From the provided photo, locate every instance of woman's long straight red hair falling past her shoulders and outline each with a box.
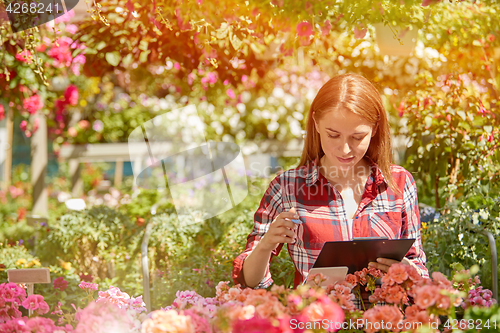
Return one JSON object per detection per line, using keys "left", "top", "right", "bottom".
{"left": 299, "top": 74, "right": 398, "bottom": 192}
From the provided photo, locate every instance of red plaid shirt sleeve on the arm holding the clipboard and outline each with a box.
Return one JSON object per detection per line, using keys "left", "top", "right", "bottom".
{"left": 401, "top": 172, "right": 429, "bottom": 277}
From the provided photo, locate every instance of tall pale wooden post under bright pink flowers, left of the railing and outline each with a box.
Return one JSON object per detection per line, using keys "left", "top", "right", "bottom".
{"left": 31, "top": 113, "right": 49, "bottom": 216}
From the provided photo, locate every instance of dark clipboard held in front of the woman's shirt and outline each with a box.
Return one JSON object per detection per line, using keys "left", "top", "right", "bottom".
{"left": 312, "top": 238, "right": 415, "bottom": 274}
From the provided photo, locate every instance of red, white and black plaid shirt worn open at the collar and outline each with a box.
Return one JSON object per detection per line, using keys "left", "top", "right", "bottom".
{"left": 232, "top": 158, "right": 429, "bottom": 288}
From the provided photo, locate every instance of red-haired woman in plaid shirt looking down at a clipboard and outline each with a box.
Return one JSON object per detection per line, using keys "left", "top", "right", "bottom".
{"left": 233, "top": 74, "right": 428, "bottom": 288}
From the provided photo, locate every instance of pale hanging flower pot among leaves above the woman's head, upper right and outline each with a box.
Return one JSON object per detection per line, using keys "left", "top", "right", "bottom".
{"left": 373, "top": 23, "right": 418, "bottom": 57}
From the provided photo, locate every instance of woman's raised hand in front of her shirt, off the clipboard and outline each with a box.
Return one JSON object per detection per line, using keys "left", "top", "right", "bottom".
{"left": 258, "top": 208, "right": 299, "bottom": 251}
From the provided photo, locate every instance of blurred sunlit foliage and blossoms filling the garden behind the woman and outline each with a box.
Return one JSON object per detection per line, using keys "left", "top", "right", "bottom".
{"left": 0, "top": 0, "right": 500, "bottom": 308}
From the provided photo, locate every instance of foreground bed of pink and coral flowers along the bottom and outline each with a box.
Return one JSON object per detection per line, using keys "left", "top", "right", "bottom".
{"left": 0, "top": 264, "right": 500, "bottom": 333}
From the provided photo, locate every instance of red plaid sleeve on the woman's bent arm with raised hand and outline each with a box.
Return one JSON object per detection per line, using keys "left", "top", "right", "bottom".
{"left": 232, "top": 176, "right": 283, "bottom": 289}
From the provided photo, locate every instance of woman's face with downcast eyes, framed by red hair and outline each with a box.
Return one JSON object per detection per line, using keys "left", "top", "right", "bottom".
{"left": 314, "top": 109, "right": 376, "bottom": 171}
